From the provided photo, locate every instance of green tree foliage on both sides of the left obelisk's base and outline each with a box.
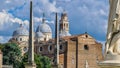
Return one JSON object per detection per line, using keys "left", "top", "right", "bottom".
{"left": 0, "top": 43, "right": 51, "bottom": 68}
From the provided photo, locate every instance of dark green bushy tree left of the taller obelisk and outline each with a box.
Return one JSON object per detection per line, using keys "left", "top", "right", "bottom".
{"left": 2, "top": 43, "right": 21, "bottom": 68}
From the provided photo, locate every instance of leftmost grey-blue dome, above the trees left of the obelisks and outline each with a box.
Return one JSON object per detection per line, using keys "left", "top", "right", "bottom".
{"left": 13, "top": 25, "right": 29, "bottom": 36}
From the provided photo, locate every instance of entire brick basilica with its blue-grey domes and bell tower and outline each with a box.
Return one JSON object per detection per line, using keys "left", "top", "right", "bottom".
{"left": 9, "top": 12, "right": 103, "bottom": 68}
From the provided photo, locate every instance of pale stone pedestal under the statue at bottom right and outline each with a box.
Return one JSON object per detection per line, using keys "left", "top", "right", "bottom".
{"left": 98, "top": 54, "right": 120, "bottom": 68}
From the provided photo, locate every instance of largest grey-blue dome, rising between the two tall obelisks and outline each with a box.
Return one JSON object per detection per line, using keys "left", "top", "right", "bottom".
{"left": 36, "top": 23, "right": 52, "bottom": 33}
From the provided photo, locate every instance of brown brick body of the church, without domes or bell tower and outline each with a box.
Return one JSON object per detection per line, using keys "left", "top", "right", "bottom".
{"left": 35, "top": 33, "right": 103, "bottom": 68}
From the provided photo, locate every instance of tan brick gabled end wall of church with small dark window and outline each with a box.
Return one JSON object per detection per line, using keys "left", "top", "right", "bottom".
{"left": 65, "top": 34, "right": 103, "bottom": 68}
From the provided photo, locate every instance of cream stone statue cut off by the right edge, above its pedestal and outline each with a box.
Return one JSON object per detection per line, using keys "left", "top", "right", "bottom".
{"left": 105, "top": 0, "right": 120, "bottom": 55}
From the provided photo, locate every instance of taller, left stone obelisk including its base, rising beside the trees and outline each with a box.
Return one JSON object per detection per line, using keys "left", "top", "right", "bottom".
{"left": 25, "top": 1, "right": 36, "bottom": 68}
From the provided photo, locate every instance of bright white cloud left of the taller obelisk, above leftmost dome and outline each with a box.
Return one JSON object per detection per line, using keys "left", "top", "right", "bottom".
{"left": 0, "top": 11, "right": 29, "bottom": 30}
